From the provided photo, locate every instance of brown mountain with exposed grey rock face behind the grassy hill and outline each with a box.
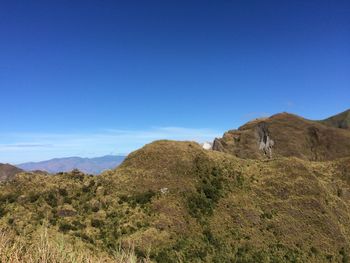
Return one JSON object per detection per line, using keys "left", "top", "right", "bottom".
{"left": 213, "top": 113, "right": 350, "bottom": 161}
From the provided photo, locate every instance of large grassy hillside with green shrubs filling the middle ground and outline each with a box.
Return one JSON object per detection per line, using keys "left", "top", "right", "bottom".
{"left": 0, "top": 141, "right": 350, "bottom": 262}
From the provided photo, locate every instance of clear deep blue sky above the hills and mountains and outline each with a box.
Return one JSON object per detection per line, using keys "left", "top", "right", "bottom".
{"left": 0, "top": 0, "right": 350, "bottom": 163}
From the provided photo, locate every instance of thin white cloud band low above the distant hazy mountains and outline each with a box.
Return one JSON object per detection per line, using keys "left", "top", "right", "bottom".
{"left": 0, "top": 127, "right": 222, "bottom": 163}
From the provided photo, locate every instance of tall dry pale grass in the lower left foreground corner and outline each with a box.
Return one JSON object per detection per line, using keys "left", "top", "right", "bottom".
{"left": 0, "top": 228, "right": 150, "bottom": 263}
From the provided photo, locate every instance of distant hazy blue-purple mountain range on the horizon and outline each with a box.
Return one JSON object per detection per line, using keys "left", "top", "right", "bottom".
{"left": 17, "top": 155, "right": 125, "bottom": 174}
